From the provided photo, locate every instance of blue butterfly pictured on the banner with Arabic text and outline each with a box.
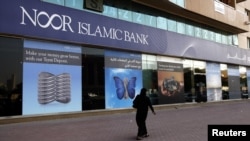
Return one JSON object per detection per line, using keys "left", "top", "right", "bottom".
{"left": 114, "top": 76, "right": 136, "bottom": 99}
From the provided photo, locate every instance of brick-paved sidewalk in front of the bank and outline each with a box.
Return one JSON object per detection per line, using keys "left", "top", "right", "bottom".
{"left": 0, "top": 100, "right": 250, "bottom": 141}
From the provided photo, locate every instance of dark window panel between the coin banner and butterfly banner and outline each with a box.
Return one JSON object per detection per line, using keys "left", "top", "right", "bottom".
{"left": 82, "top": 47, "right": 105, "bottom": 110}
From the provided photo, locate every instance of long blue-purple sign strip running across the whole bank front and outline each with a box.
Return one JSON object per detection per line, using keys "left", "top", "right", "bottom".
{"left": 0, "top": 0, "right": 250, "bottom": 66}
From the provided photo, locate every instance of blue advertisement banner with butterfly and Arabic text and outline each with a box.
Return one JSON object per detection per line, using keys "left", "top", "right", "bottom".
{"left": 105, "top": 51, "right": 142, "bottom": 109}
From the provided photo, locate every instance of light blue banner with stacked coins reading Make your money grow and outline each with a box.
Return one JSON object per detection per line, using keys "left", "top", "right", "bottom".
{"left": 23, "top": 40, "right": 82, "bottom": 115}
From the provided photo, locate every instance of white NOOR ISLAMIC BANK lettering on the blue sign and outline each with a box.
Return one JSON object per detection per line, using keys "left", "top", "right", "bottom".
{"left": 20, "top": 6, "right": 149, "bottom": 45}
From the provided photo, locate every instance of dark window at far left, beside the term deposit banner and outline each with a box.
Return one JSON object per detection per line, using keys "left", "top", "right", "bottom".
{"left": 0, "top": 37, "right": 23, "bottom": 116}
